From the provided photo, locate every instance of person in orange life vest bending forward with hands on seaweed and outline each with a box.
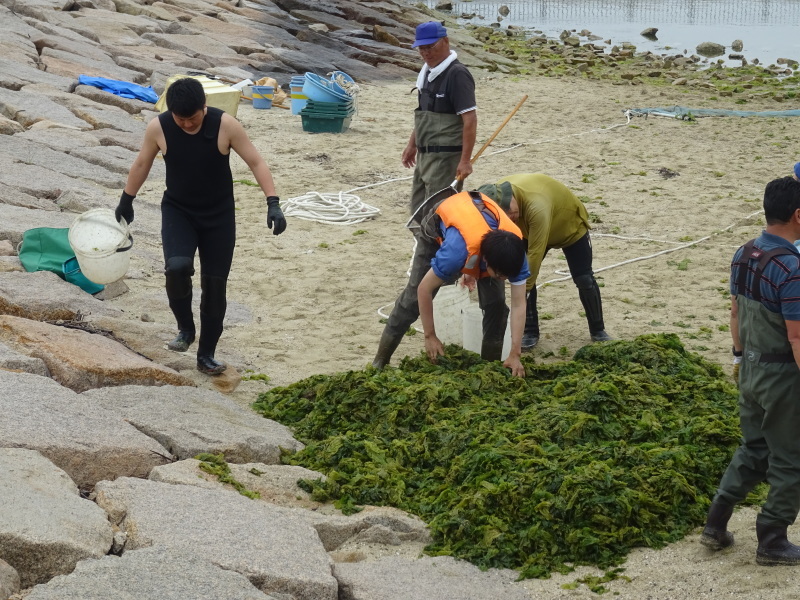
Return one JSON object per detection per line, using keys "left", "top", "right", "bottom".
{"left": 417, "top": 192, "right": 530, "bottom": 377}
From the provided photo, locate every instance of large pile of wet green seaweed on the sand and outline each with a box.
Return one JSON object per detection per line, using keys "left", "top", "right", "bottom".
{"left": 254, "top": 334, "right": 740, "bottom": 578}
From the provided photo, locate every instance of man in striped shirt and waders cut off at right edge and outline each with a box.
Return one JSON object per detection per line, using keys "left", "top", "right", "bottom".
{"left": 700, "top": 177, "right": 800, "bottom": 565}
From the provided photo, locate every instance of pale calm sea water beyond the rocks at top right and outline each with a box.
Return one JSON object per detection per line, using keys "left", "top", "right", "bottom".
{"left": 426, "top": 0, "right": 800, "bottom": 65}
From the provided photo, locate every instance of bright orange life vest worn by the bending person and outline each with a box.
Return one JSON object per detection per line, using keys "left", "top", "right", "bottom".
{"left": 436, "top": 192, "right": 522, "bottom": 279}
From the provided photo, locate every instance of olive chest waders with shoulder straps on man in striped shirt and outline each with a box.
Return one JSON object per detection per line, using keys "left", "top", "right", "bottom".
{"left": 704, "top": 241, "right": 800, "bottom": 565}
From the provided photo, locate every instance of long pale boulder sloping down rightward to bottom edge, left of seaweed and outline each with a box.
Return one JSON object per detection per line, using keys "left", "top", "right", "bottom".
{"left": 96, "top": 477, "right": 338, "bottom": 600}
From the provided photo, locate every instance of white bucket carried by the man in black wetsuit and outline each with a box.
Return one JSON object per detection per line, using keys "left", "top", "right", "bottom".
{"left": 68, "top": 208, "right": 133, "bottom": 284}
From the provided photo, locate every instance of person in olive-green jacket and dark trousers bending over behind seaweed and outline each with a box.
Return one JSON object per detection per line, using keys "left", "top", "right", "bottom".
{"left": 478, "top": 173, "right": 612, "bottom": 350}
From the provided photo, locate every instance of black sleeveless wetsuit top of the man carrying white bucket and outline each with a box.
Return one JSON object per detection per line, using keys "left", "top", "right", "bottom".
{"left": 158, "top": 106, "right": 234, "bottom": 216}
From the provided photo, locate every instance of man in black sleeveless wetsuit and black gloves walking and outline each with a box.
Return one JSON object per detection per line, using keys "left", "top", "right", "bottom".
{"left": 116, "top": 77, "right": 286, "bottom": 375}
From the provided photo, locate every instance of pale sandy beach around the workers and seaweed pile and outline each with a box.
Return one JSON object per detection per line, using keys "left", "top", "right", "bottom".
{"left": 111, "top": 69, "right": 800, "bottom": 599}
